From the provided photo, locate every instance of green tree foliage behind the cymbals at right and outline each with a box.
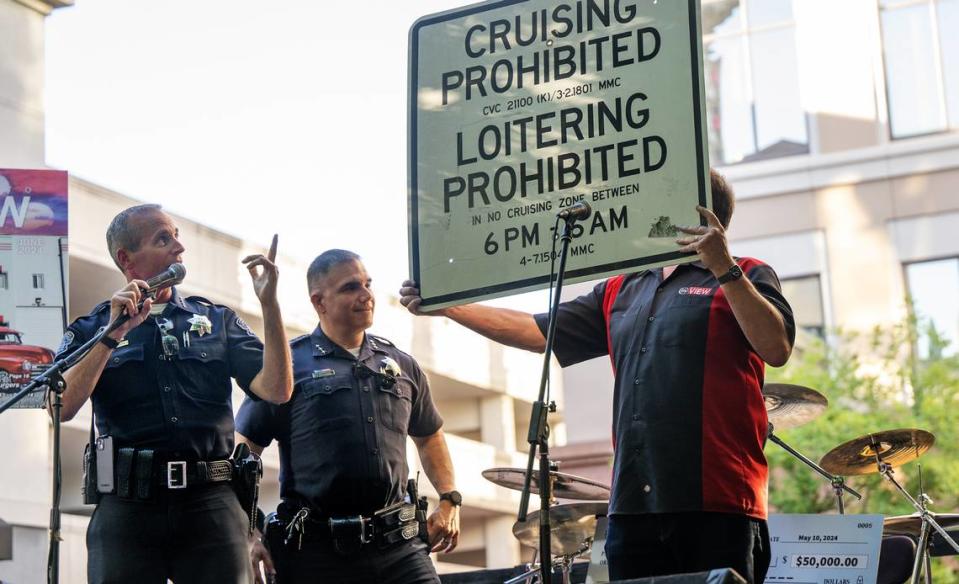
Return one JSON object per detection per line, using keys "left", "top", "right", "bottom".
{"left": 766, "top": 316, "right": 959, "bottom": 582}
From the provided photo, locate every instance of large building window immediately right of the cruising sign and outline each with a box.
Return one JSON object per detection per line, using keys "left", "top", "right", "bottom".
{"left": 702, "top": 0, "right": 809, "bottom": 164}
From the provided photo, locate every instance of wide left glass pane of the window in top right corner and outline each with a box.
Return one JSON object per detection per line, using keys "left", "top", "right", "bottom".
{"left": 882, "top": 4, "right": 945, "bottom": 138}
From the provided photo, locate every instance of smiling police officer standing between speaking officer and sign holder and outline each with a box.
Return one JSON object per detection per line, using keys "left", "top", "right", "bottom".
{"left": 237, "top": 250, "right": 460, "bottom": 584}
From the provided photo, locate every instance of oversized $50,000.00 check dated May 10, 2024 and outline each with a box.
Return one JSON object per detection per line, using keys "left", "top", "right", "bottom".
{"left": 766, "top": 515, "right": 883, "bottom": 584}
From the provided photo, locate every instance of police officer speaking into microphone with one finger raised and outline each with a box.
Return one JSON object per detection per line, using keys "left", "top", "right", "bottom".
{"left": 58, "top": 205, "right": 291, "bottom": 584}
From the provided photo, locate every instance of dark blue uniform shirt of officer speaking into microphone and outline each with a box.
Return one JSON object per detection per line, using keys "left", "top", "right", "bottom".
{"left": 57, "top": 288, "right": 263, "bottom": 460}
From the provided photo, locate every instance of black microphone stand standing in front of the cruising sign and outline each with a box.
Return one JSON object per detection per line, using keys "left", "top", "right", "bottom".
{"left": 517, "top": 216, "right": 576, "bottom": 584}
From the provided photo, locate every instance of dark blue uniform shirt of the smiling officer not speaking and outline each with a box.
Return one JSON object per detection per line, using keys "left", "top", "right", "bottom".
{"left": 236, "top": 327, "right": 443, "bottom": 516}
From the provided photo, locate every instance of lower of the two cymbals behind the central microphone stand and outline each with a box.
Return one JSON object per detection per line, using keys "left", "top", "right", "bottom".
{"left": 513, "top": 503, "right": 609, "bottom": 556}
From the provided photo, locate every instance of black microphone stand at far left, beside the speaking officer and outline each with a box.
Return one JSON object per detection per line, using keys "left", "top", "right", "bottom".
{"left": 0, "top": 299, "right": 145, "bottom": 584}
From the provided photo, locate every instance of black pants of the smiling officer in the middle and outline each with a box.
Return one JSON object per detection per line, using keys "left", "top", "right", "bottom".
{"left": 274, "top": 539, "right": 440, "bottom": 584}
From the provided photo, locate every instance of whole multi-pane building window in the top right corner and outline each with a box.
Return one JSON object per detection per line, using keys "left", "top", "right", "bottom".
{"left": 879, "top": 0, "right": 959, "bottom": 138}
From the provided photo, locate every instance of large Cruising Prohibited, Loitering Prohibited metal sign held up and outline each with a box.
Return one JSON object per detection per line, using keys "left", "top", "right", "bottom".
{"left": 409, "top": 0, "right": 712, "bottom": 309}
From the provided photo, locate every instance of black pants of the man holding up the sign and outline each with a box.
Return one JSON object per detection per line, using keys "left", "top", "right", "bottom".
{"left": 606, "top": 513, "right": 770, "bottom": 584}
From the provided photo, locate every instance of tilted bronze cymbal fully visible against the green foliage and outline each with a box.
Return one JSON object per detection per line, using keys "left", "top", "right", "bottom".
{"left": 819, "top": 428, "right": 936, "bottom": 475}
